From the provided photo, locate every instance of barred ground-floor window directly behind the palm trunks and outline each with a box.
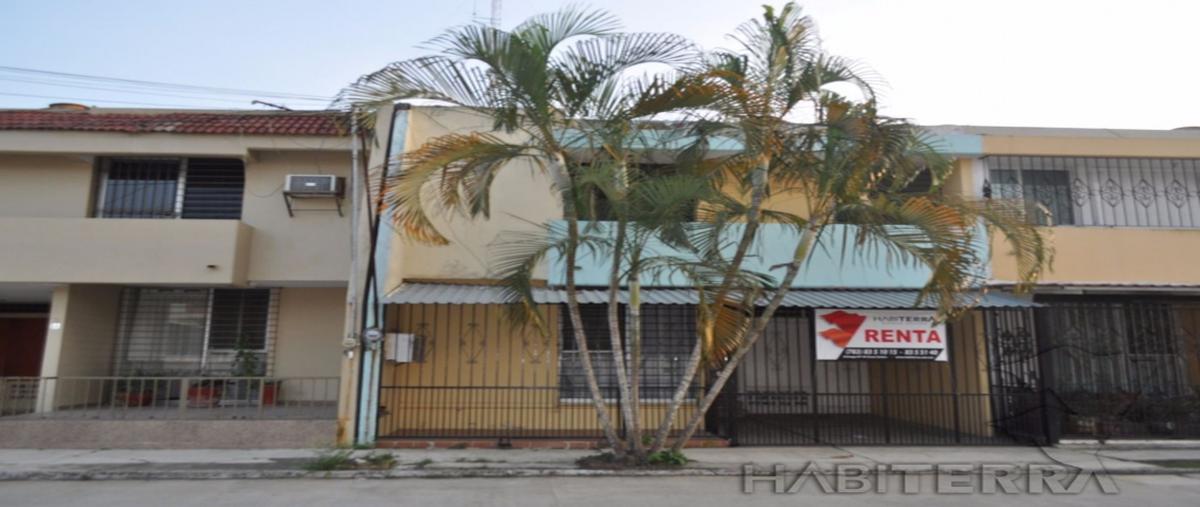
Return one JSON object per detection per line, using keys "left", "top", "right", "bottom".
{"left": 558, "top": 304, "right": 696, "bottom": 400}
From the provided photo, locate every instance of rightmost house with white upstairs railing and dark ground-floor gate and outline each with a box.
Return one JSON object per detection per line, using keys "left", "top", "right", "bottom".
{"left": 955, "top": 126, "right": 1200, "bottom": 440}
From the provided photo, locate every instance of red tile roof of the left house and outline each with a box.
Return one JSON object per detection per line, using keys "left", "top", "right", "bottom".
{"left": 0, "top": 109, "right": 348, "bottom": 136}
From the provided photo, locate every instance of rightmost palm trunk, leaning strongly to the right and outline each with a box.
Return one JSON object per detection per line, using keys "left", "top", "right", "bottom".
{"left": 671, "top": 220, "right": 823, "bottom": 451}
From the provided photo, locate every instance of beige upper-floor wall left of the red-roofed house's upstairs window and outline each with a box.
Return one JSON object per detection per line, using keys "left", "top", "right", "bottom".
{"left": 0, "top": 154, "right": 92, "bottom": 217}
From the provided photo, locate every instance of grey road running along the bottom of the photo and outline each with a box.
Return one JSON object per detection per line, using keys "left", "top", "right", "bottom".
{"left": 0, "top": 475, "right": 1200, "bottom": 507}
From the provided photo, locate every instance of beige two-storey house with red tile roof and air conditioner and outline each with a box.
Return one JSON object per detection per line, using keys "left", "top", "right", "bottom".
{"left": 0, "top": 105, "right": 352, "bottom": 447}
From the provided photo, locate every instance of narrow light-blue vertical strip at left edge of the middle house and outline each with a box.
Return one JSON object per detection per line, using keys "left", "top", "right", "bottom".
{"left": 355, "top": 103, "right": 408, "bottom": 443}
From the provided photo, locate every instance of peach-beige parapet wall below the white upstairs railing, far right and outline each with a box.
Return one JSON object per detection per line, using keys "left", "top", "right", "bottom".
{"left": 991, "top": 227, "right": 1200, "bottom": 285}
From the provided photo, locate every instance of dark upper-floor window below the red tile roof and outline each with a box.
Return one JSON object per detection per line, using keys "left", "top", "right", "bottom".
{"left": 96, "top": 159, "right": 245, "bottom": 219}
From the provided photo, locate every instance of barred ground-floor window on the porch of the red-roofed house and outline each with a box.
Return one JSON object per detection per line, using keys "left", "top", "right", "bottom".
{"left": 116, "top": 287, "right": 275, "bottom": 375}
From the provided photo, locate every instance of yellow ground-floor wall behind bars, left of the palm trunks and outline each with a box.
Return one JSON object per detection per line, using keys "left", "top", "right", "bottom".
{"left": 379, "top": 305, "right": 691, "bottom": 436}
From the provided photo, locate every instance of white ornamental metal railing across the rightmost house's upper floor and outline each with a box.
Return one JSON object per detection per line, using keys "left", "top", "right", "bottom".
{"left": 986, "top": 156, "right": 1200, "bottom": 228}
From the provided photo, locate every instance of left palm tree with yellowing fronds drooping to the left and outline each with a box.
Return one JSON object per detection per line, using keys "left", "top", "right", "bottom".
{"left": 338, "top": 8, "right": 696, "bottom": 456}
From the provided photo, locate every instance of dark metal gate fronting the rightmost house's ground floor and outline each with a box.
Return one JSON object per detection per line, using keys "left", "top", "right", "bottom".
{"left": 1038, "top": 297, "right": 1200, "bottom": 439}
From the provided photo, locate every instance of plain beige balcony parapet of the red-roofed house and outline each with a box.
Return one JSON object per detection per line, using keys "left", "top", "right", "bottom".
{"left": 0, "top": 217, "right": 252, "bottom": 285}
